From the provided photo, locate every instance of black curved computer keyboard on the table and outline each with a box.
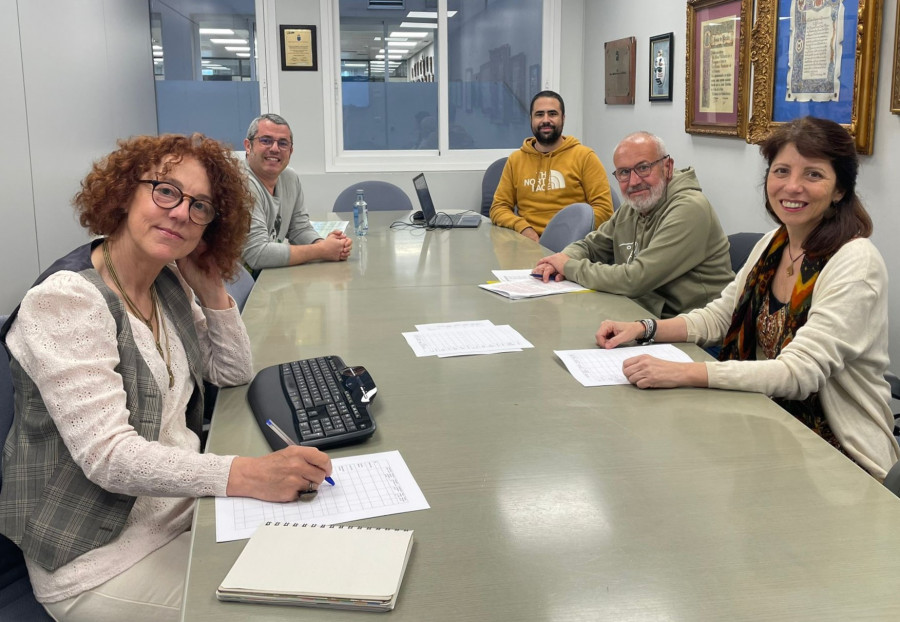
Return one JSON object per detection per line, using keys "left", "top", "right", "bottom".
{"left": 247, "top": 355, "right": 377, "bottom": 449}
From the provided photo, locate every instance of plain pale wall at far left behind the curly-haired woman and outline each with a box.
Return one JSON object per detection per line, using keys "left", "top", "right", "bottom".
{"left": 0, "top": 0, "right": 156, "bottom": 313}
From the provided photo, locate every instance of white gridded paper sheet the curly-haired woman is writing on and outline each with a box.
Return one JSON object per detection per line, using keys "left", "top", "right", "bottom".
{"left": 216, "top": 451, "right": 431, "bottom": 542}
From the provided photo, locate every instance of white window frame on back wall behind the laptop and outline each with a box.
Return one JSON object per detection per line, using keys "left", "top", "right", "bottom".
{"left": 312, "top": 0, "right": 562, "bottom": 173}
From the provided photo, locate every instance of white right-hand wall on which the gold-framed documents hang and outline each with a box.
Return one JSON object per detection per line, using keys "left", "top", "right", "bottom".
{"left": 584, "top": 0, "right": 900, "bottom": 368}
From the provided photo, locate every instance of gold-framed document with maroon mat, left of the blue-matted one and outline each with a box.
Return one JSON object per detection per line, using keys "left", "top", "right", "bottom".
{"left": 684, "top": 0, "right": 753, "bottom": 138}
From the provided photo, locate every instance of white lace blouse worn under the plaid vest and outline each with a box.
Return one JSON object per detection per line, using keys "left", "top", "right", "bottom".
{"left": 7, "top": 266, "right": 252, "bottom": 602}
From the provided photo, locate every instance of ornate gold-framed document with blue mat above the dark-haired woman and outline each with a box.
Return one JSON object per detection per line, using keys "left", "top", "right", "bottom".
{"left": 747, "top": 0, "right": 883, "bottom": 154}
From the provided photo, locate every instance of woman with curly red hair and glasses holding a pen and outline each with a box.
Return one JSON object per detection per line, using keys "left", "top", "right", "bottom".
{"left": 0, "top": 134, "right": 331, "bottom": 622}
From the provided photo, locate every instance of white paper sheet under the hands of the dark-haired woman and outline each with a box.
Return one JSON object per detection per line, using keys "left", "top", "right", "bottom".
{"left": 553, "top": 343, "right": 693, "bottom": 387}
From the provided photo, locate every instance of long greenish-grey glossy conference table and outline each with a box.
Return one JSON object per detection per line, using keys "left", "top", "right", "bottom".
{"left": 182, "top": 212, "right": 900, "bottom": 622}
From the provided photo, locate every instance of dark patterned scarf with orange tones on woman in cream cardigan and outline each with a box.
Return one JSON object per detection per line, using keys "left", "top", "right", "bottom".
{"left": 719, "top": 227, "right": 839, "bottom": 447}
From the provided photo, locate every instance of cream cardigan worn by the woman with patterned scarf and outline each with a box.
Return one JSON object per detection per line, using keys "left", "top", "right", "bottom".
{"left": 679, "top": 231, "right": 900, "bottom": 480}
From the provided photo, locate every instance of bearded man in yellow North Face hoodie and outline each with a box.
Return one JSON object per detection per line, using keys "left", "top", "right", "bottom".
{"left": 490, "top": 91, "right": 613, "bottom": 242}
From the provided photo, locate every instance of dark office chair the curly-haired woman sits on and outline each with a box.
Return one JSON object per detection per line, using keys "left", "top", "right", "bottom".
{"left": 0, "top": 315, "right": 52, "bottom": 622}
